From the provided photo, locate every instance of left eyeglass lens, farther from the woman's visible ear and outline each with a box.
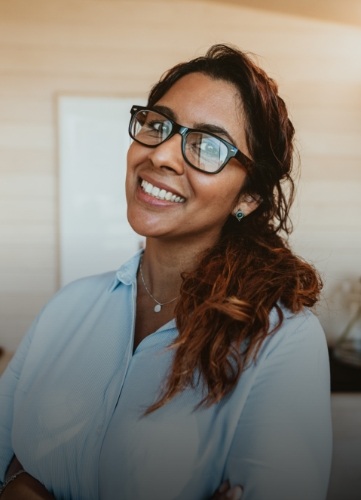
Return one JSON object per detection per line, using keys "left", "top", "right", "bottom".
{"left": 130, "top": 110, "right": 172, "bottom": 146}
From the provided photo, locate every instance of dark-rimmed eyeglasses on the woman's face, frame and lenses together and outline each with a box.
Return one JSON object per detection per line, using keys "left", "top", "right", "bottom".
{"left": 129, "top": 106, "right": 253, "bottom": 174}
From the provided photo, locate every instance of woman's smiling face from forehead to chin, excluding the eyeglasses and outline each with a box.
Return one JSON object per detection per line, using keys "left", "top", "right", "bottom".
{"left": 126, "top": 73, "right": 253, "bottom": 248}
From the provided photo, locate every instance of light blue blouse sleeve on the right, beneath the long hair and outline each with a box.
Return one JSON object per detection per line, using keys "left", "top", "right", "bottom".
{"left": 225, "top": 314, "right": 332, "bottom": 500}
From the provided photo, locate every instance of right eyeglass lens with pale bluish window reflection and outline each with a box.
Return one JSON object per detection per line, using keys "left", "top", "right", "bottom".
{"left": 184, "top": 131, "right": 228, "bottom": 172}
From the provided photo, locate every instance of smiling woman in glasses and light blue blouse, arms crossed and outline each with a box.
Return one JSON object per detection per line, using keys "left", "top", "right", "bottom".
{"left": 0, "top": 45, "right": 331, "bottom": 500}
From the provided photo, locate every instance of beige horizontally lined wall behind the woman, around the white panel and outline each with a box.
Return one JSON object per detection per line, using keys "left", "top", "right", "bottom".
{"left": 0, "top": 0, "right": 361, "bottom": 349}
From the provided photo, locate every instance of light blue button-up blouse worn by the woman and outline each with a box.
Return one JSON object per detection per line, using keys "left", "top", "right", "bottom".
{"left": 0, "top": 253, "right": 332, "bottom": 500}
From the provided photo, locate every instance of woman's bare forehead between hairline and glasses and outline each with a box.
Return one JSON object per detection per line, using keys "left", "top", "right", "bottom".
{"left": 156, "top": 73, "right": 244, "bottom": 129}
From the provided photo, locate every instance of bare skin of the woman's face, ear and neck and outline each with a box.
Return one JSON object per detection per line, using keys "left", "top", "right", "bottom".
{"left": 126, "top": 73, "right": 257, "bottom": 347}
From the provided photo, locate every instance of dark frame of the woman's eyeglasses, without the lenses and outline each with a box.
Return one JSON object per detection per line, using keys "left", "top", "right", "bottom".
{"left": 128, "top": 105, "right": 254, "bottom": 175}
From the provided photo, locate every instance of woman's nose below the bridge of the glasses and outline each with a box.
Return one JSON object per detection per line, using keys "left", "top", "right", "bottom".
{"left": 149, "top": 133, "right": 185, "bottom": 175}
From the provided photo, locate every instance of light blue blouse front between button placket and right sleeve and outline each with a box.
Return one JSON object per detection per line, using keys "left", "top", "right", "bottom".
{"left": 99, "top": 348, "right": 234, "bottom": 500}
